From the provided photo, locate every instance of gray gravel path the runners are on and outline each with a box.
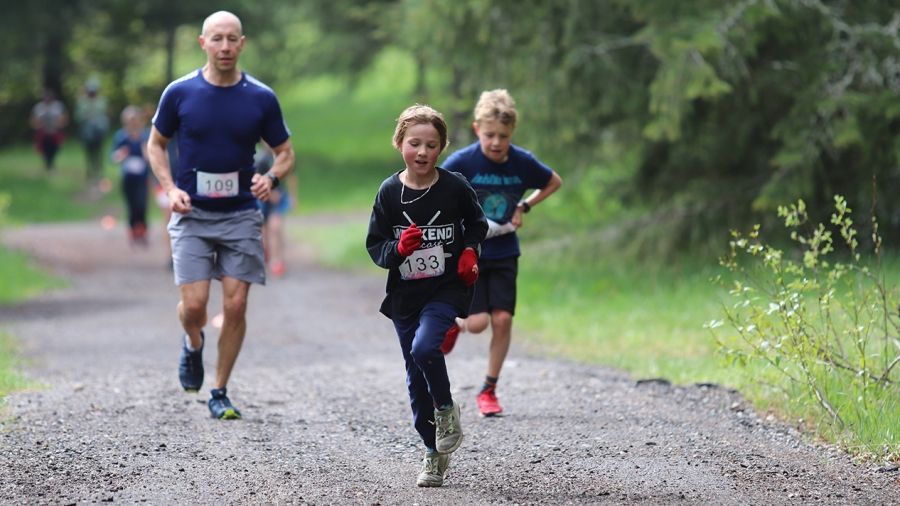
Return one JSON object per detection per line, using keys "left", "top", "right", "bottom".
{"left": 0, "top": 219, "right": 900, "bottom": 504}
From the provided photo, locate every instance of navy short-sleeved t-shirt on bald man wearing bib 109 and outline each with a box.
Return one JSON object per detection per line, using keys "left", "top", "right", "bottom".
{"left": 153, "top": 69, "right": 291, "bottom": 212}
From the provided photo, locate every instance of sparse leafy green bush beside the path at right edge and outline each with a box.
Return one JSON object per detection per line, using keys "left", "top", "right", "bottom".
{"left": 708, "top": 196, "right": 900, "bottom": 458}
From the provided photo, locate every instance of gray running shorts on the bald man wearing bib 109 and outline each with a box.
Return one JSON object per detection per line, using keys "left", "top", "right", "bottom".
{"left": 168, "top": 207, "right": 266, "bottom": 286}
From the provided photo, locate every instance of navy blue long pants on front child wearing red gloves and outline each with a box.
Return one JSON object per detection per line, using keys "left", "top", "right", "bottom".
{"left": 394, "top": 302, "right": 457, "bottom": 448}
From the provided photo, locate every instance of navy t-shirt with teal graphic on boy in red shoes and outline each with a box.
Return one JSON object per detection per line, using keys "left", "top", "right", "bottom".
{"left": 441, "top": 141, "right": 553, "bottom": 259}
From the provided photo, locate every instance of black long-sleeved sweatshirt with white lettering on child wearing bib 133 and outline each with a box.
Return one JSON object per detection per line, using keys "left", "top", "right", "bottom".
{"left": 366, "top": 167, "right": 488, "bottom": 318}
